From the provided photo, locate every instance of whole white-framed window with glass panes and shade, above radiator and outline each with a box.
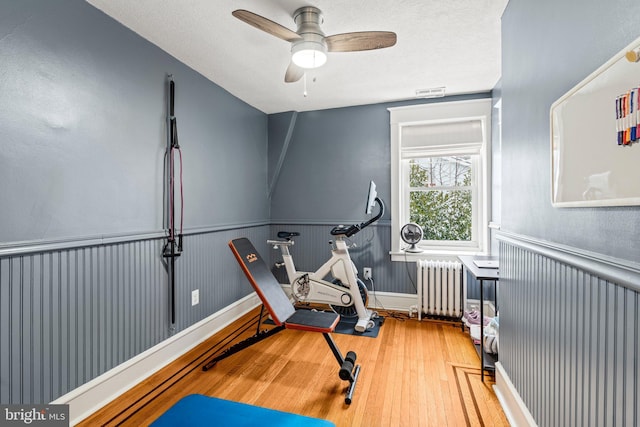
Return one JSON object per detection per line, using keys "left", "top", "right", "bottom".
{"left": 390, "top": 99, "right": 491, "bottom": 260}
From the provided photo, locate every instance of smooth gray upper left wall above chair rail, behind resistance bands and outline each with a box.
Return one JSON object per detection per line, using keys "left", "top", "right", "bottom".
{"left": 0, "top": 0, "right": 269, "bottom": 243}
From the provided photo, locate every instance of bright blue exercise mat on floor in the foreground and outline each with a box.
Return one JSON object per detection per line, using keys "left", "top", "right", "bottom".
{"left": 151, "top": 394, "right": 335, "bottom": 427}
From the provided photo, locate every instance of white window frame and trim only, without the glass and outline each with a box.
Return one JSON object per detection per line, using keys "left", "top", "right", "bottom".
{"left": 388, "top": 98, "right": 492, "bottom": 261}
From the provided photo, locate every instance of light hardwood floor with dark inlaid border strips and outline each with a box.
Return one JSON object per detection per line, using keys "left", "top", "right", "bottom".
{"left": 80, "top": 310, "right": 508, "bottom": 427}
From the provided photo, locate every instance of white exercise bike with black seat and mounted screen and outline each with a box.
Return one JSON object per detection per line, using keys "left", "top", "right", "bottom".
{"left": 267, "top": 181, "right": 384, "bottom": 332}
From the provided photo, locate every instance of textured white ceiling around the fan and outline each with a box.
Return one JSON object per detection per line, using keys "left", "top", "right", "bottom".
{"left": 87, "top": 0, "right": 508, "bottom": 113}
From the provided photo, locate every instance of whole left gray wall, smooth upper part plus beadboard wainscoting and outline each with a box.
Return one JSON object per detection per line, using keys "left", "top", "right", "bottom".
{"left": 0, "top": 0, "right": 269, "bottom": 403}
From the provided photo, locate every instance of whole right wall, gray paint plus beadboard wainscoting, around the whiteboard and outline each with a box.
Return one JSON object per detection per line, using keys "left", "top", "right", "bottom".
{"left": 498, "top": 0, "right": 640, "bottom": 426}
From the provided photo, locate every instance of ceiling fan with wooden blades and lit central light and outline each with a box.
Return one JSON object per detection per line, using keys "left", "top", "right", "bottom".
{"left": 232, "top": 6, "right": 396, "bottom": 83}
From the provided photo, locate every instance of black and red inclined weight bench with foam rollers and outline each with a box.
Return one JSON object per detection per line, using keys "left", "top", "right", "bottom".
{"left": 202, "top": 237, "right": 360, "bottom": 404}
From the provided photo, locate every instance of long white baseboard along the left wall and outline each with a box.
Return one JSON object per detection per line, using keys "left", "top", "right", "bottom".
{"left": 51, "top": 293, "right": 260, "bottom": 425}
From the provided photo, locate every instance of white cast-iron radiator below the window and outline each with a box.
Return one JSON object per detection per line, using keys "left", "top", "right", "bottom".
{"left": 416, "top": 260, "right": 463, "bottom": 320}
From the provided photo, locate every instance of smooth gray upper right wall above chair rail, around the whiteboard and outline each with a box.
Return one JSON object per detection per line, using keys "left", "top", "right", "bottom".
{"left": 501, "top": 0, "right": 640, "bottom": 261}
